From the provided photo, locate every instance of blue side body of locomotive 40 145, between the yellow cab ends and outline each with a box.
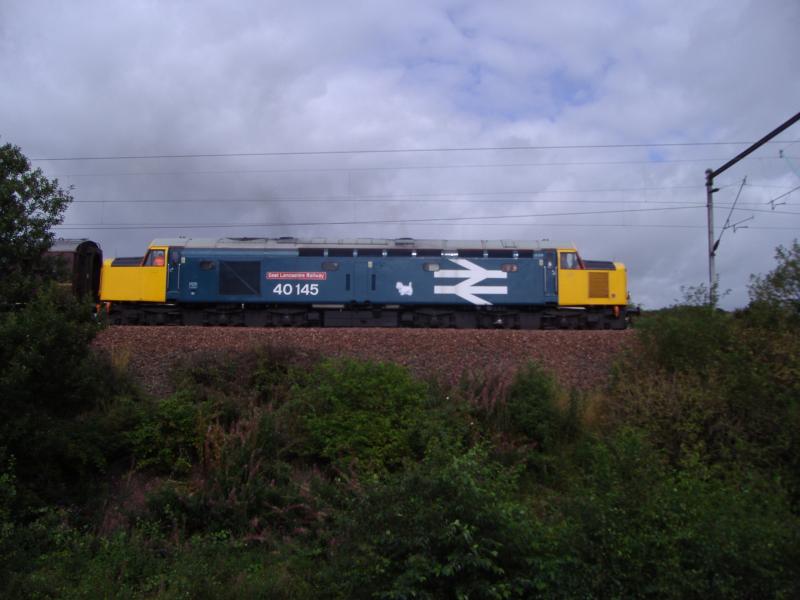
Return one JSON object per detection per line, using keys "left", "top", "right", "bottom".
{"left": 166, "top": 248, "right": 558, "bottom": 306}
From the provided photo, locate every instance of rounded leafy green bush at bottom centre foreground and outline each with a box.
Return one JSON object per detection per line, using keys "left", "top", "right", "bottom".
{"left": 320, "top": 448, "right": 535, "bottom": 598}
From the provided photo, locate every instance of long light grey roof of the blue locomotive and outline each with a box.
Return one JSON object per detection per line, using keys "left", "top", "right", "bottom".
{"left": 150, "top": 237, "right": 575, "bottom": 250}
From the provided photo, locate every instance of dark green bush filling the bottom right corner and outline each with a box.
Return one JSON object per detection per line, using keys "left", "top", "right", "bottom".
{"left": 535, "top": 430, "right": 800, "bottom": 598}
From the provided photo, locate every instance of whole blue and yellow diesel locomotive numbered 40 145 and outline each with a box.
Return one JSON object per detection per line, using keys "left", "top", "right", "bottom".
{"left": 86, "top": 237, "right": 632, "bottom": 329}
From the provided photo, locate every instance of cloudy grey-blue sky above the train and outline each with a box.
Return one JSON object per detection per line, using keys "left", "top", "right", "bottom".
{"left": 0, "top": 0, "right": 800, "bottom": 308}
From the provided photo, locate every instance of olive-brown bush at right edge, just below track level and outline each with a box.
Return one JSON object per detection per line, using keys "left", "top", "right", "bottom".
{"left": 599, "top": 307, "right": 800, "bottom": 505}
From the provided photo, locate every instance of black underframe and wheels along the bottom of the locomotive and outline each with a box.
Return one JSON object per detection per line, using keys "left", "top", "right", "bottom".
{"left": 101, "top": 302, "right": 628, "bottom": 329}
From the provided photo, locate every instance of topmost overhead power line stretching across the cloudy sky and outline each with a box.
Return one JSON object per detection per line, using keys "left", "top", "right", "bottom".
{"left": 30, "top": 141, "right": 786, "bottom": 161}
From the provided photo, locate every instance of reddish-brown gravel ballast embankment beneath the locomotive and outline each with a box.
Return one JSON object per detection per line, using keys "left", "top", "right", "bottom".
{"left": 95, "top": 326, "right": 635, "bottom": 394}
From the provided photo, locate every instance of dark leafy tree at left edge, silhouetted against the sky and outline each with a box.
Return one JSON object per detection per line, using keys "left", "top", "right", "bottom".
{"left": 0, "top": 144, "right": 72, "bottom": 305}
